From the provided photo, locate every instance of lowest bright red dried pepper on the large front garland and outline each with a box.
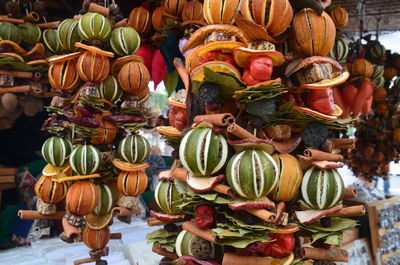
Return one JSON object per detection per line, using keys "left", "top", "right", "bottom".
{"left": 262, "top": 233, "right": 295, "bottom": 258}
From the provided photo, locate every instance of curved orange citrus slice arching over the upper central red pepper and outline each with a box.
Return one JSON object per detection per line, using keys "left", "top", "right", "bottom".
{"left": 233, "top": 47, "right": 285, "bottom": 67}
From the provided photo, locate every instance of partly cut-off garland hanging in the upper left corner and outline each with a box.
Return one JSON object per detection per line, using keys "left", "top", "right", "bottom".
{"left": 0, "top": 1, "right": 57, "bottom": 130}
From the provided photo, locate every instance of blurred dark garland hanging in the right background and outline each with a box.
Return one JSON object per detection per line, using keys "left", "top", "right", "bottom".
{"left": 345, "top": 36, "right": 400, "bottom": 180}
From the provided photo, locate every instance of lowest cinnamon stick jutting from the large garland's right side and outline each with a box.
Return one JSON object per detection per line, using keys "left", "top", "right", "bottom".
{"left": 301, "top": 247, "right": 349, "bottom": 262}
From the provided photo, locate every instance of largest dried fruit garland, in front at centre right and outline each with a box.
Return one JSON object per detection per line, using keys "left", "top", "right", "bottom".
{"left": 147, "top": 0, "right": 365, "bottom": 265}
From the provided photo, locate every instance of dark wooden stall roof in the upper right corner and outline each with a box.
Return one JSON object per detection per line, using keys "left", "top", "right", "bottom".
{"left": 332, "top": 0, "right": 400, "bottom": 32}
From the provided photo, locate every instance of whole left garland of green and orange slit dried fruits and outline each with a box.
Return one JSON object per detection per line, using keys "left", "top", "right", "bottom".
{"left": 16, "top": 1, "right": 150, "bottom": 264}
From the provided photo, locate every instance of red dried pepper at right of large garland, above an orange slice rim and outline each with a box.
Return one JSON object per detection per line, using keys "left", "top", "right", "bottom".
{"left": 308, "top": 88, "right": 335, "bottom": 115}
